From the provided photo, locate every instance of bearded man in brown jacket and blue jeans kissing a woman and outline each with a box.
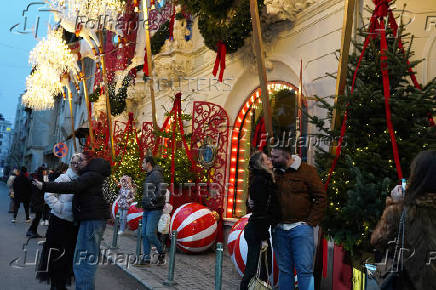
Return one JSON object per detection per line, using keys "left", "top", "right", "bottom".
{"left": 271, "top": 147, "right": 327, "bottom": 290}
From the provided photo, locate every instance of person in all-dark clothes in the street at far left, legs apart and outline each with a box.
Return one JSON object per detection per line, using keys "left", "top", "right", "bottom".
{"left": 12, "top": 167, "right": 32, "bottom": 223}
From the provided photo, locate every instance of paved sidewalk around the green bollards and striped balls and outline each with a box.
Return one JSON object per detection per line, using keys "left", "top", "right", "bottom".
{"left": 101, "top": 225, "right": 241, "bottom": 290}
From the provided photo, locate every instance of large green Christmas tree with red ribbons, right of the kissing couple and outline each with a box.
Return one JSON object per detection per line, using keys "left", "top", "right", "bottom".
{"left": 310, "top": 12, "right": 436, "bottom": 257}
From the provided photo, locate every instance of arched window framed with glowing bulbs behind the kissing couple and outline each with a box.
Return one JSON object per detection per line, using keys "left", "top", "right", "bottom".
{"left": 226, "top": 81, "right": 307, "bottom": 218}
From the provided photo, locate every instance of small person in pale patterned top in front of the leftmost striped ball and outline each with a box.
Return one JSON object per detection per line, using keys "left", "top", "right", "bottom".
{"left": 118, "top": 175, "right": 136, "bottom": 235}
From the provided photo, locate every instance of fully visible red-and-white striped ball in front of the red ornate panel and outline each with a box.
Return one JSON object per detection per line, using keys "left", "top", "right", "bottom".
{"left": 170, "top": 202, "right": 217, "bottom": 253}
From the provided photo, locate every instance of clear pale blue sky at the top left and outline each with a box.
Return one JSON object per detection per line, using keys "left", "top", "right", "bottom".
{"left": 0, "top": 0, "right": 53, "bottom": 123}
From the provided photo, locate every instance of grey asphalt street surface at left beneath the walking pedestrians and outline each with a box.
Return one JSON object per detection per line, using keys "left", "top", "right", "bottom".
{"left": 0, "top": 182, "right": 145, "bottom": 290}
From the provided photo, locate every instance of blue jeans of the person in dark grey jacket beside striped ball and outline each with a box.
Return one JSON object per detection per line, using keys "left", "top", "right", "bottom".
{"left": 142, "top": 209, "right": 163, "bottom": 258}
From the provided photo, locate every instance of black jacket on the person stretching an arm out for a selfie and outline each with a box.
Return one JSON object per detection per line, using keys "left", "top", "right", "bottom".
{"left": 43, "top": 158, "right": 111, "bottom": 221}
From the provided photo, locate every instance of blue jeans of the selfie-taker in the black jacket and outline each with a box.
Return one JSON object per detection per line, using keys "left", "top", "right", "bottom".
{"left": 73, "top": 220, "right": 106, "bottom": 290}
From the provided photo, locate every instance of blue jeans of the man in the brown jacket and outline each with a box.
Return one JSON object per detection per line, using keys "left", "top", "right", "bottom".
{"left": 272, "top": 225, "right": 315, "bottom": 290}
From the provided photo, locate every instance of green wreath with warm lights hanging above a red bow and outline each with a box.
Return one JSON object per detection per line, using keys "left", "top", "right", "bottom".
{"left": 179, "top": 0, "right": 264, "bottom": 53}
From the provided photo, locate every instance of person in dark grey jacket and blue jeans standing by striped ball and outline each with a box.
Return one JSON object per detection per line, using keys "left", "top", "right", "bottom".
{"left": 139, "top": 156, "right": 167, "bottom": 265}
